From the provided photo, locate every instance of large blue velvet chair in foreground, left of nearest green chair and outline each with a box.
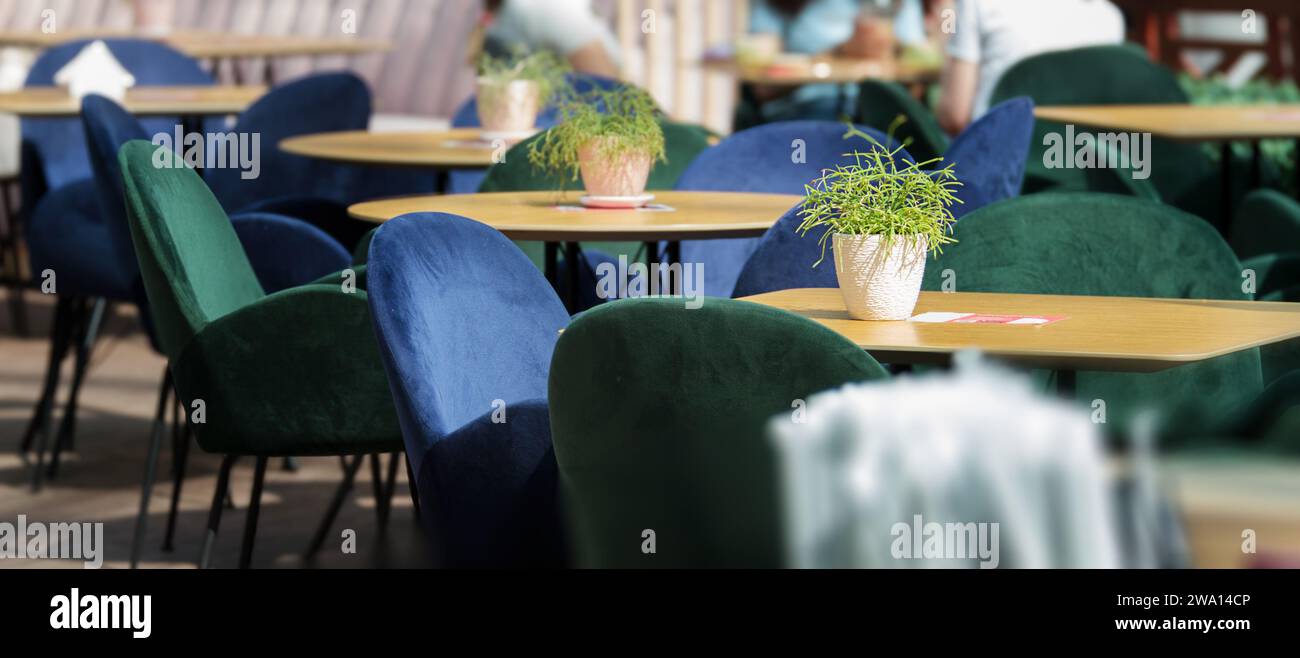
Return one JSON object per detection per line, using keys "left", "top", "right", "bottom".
{"left": 368, "top": 213, "right": 569, "bottom": 567}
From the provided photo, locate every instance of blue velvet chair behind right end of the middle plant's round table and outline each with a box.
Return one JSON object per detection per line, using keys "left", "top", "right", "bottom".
{"left": 677, "top": 121, "right": 911, "bottom": 296}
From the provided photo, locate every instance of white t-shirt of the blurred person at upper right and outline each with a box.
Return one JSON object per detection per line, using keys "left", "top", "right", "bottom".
{"left": 948, "top": 0, "right": 1125, "bottom": 117}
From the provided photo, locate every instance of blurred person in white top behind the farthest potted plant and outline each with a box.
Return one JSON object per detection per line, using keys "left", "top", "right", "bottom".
{"left": 482, "top": 0, "right": 620, "bottom": 78}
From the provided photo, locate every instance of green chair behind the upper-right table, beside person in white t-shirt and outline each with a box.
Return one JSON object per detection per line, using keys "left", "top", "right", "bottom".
{"left": 991, "top": 46, "right": 1216, "bottom": 208}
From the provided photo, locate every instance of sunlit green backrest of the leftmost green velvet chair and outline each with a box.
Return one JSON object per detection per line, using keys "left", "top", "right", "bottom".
{"left": 118, "top": 140, "right": 265, "bottom": 359}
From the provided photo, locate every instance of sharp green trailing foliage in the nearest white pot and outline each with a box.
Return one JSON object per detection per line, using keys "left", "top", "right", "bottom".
{"left": 797, "top": 120, "right": 962, "bottom": 267}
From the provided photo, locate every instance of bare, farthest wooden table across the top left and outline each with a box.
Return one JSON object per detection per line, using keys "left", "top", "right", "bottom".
{"left": 0, "top": 29, "right": 393, "bottom": 85}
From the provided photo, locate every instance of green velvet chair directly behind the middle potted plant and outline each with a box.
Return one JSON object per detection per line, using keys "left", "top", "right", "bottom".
{"left": 478, "top": 120, "right": 716, "bottom": 268}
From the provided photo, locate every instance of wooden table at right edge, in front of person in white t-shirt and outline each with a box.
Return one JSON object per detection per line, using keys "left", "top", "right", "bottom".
{"left": 1034, "top": 104, "right": 1300, "bottom": 221}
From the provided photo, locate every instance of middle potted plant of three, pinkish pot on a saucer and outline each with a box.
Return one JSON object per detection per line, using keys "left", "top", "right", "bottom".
{"left": 528, "top": 86, "right": 666, "bottom": 208}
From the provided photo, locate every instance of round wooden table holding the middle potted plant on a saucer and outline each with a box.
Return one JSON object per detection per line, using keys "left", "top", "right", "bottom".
{"left": 348, "top": 191, "right": 803, "bottom": 308}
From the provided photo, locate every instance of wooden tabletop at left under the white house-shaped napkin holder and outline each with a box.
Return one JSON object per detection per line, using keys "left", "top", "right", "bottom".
{"left": 0, "top": 86, "right": 267, "bottom": 118}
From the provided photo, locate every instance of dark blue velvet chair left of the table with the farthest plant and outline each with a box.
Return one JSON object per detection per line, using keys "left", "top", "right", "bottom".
{"left": 204, "top": 73, "right": 434, "bottom": 250}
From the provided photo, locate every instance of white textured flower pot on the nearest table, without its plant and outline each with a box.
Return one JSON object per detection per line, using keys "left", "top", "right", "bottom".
{"left": 833, "top": 233, "right": 927, "bottom": 320}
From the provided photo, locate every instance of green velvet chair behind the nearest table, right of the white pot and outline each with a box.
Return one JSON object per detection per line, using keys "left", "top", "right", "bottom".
{"left": 924, "top": 192, "right": 1262, "bottom": 434}
